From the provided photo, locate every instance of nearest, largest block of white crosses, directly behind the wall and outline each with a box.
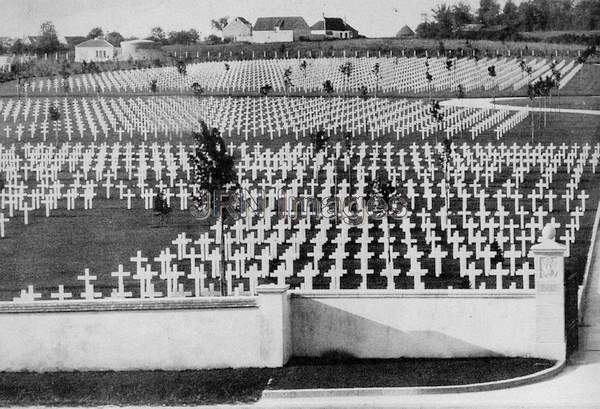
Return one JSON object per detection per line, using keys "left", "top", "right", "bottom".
{"left": 8, "top": 139, "right": 600, "bottom": 299}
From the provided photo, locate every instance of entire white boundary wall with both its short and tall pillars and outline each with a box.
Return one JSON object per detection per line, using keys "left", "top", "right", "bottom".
{"left": 0, "top": 241, "right": 566, "bottom": 371}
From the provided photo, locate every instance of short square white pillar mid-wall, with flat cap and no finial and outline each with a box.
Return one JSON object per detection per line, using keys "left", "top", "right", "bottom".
{"left": 256, "top": 284, "right": 292, "bottom": 368}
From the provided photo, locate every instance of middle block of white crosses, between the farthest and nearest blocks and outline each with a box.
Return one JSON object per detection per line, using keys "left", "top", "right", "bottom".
{"left": 0, "top": 97, "right": 528, "bottom": 142}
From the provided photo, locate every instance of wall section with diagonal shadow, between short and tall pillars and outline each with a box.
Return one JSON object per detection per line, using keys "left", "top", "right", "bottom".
{"left": 291, "top": 290, "right": 536, "bottom": 358}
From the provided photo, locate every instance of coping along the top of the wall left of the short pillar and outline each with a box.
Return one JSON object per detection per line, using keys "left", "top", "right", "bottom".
{"left": 0, "top": 296, "right": 258, "bottom": 314}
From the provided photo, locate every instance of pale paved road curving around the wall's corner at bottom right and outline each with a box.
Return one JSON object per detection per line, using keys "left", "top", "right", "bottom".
{"left": 256, "top": 226, "right": 600, "bottom": 409}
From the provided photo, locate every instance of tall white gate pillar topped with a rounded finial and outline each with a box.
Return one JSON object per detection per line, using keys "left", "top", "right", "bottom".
{"left": 531, "top": 224, "right": 567, "bottom": 360}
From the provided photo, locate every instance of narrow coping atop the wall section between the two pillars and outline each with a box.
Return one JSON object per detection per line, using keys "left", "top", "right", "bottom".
{"left": 290, "top": 289, "right": 536, "bottom": 298}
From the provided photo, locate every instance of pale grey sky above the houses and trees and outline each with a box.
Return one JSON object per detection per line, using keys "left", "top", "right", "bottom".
{"left": 0, "top": 0, "right": 516, "bottom": 38}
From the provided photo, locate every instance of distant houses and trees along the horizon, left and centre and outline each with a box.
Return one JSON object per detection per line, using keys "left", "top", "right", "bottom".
{"left": 0, "top": 16, "right": 415, "bottom": 72}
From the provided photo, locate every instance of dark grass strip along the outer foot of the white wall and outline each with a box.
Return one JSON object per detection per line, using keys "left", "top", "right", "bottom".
{"left": 0, "top": 356, "right": 554, "bottom": 406}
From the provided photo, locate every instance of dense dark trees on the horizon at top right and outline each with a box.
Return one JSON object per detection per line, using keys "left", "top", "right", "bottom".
{"left": 417, "top": 0, "right": 600, "bottom": 40}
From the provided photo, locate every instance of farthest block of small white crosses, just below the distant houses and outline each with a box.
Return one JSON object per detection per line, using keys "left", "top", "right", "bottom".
{"left": 21, "top": 56, "right": 578, "bottom": 93}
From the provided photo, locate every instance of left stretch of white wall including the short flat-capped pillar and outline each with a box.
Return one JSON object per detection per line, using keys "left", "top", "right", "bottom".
{"left": 0, "top": 287, "right": 291, "bottom": 372}
